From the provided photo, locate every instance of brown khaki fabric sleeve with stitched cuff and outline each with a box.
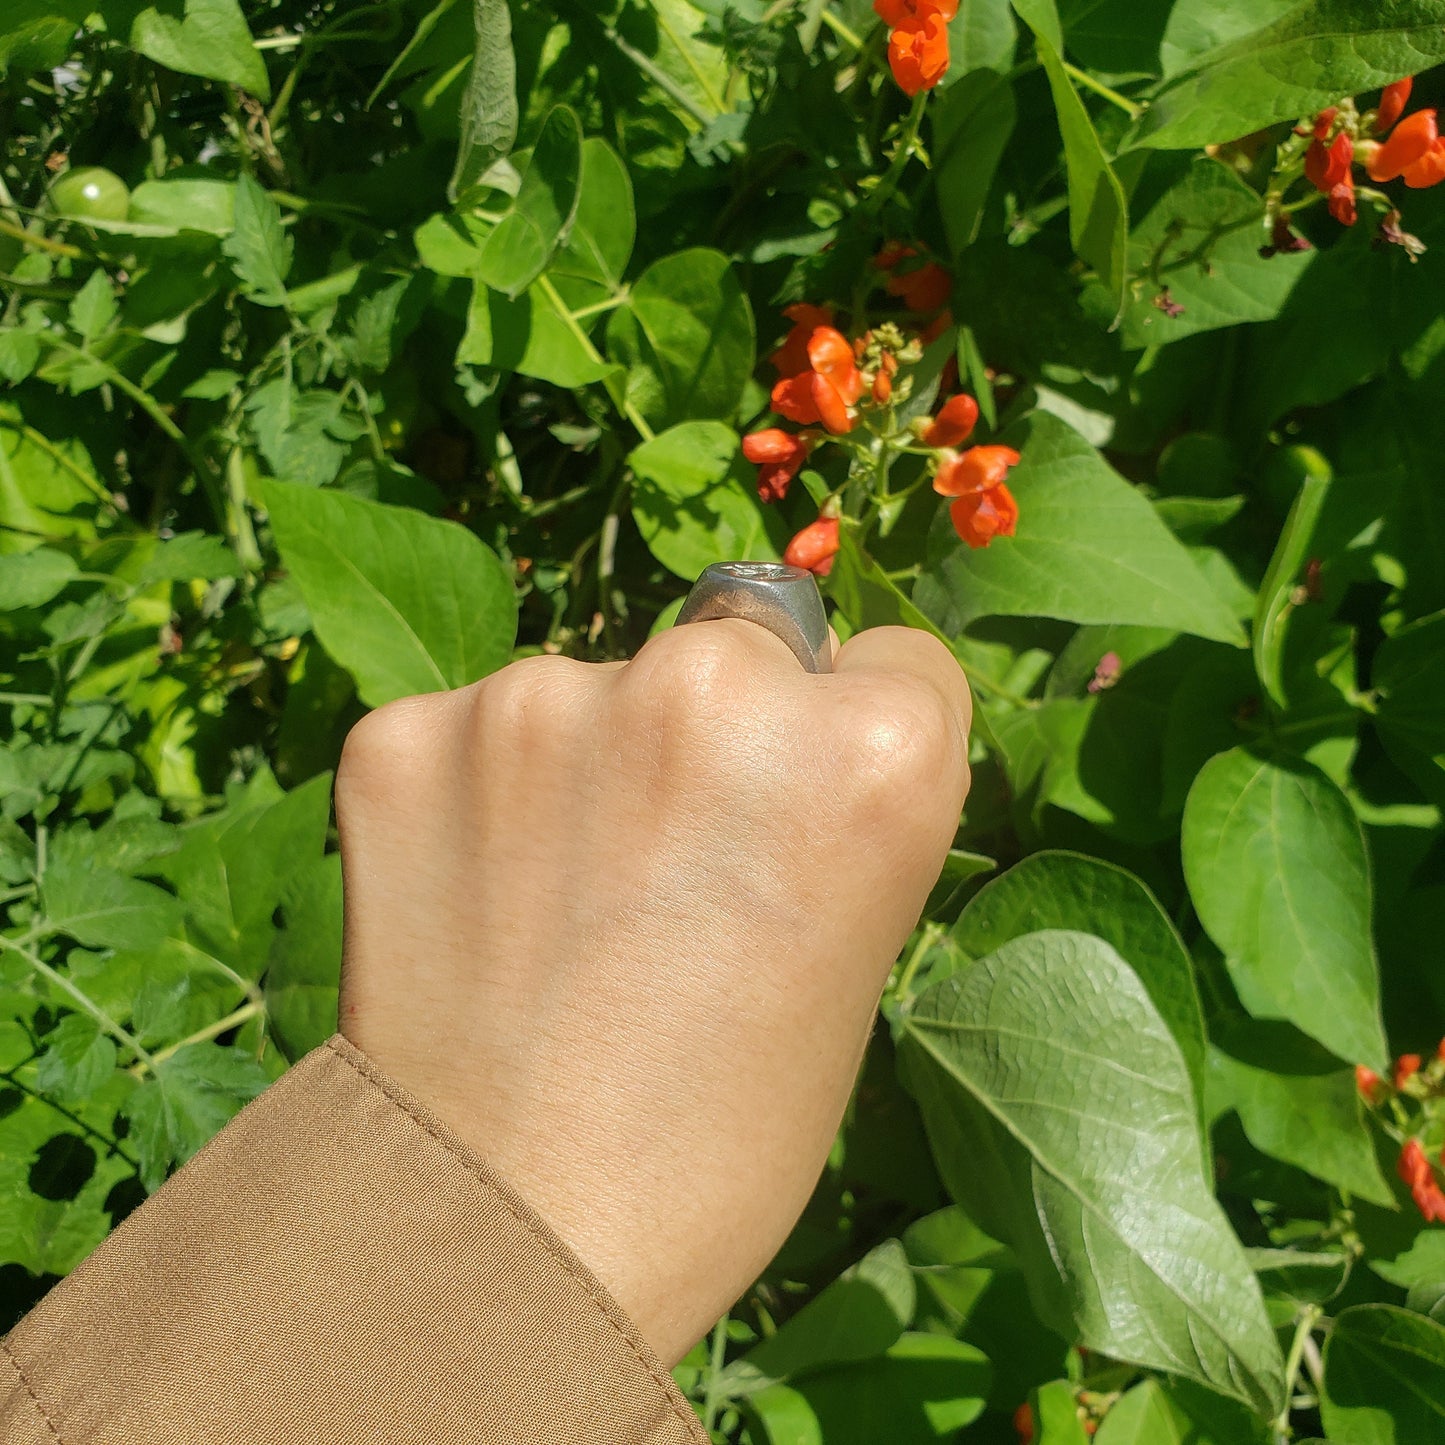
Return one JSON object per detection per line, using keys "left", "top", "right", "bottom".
{"left": 0, "top": 1035, "right": 707, "bottom": 1445}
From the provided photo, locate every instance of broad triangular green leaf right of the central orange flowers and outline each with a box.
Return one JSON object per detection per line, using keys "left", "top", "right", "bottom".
{"left": 913, "top": 413, "right": 1244, "bottom": 646}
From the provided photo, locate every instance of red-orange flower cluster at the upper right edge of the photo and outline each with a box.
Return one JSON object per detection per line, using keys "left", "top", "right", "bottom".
{"left": 1302, "top": 75, "right": 1445, "bottom": 225}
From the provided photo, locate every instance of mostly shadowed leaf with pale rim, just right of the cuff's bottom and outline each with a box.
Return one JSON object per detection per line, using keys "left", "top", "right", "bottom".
{"left": 718, "top": 1240, "right": 916, "bottom": 1397}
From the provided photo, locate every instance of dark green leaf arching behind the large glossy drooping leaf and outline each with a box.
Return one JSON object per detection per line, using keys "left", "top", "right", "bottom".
{"left": 947, "top": 851, "right": 1208, "bottom": 1168}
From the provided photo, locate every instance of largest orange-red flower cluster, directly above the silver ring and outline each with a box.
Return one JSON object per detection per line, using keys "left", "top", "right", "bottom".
{"left": 743, "top": 284, "right": 1019, "bottom": 577}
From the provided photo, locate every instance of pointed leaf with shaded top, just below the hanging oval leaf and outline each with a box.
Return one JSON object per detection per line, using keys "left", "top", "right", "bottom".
{"left": 1209, "top": 1019, "right": 1394, "bottom": 1208}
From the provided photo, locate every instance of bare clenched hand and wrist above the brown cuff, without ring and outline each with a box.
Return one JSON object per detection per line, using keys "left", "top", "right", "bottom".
{"left": 337, "top": 620, "right": 971, "bottom": 1366}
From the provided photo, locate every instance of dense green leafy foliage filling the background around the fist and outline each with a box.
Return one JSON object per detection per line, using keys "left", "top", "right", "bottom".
{"left": 0, "top": 0, "right": 1445, "bottom": 1445}
